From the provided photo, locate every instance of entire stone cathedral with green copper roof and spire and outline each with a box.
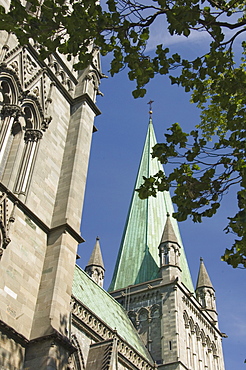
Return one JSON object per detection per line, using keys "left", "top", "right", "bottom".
{"left": 0, "top": 11, "right": 224, "bottom": 370}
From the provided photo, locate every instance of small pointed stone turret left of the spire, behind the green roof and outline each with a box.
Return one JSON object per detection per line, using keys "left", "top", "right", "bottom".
{"left": 85, "top": 237, "right": 105, "bottom": 287}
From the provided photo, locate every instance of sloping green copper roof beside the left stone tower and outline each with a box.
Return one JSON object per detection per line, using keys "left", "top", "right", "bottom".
{"left": 72, "top": 265, "right": 153, "bottom": 363}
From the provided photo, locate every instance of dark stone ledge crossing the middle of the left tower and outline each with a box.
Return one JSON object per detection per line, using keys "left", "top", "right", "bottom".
{"left": 0, "top": 183, "right": 85, "bottom": 243}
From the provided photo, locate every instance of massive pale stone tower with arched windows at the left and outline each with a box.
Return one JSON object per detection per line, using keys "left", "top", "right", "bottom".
{"left": 0, "top": 24, "right": 101, "bottom": 370}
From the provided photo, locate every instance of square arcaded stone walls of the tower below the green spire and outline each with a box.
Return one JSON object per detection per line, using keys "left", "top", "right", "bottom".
{"left": 112, "top": 279, "right": 224, "bottom": 370}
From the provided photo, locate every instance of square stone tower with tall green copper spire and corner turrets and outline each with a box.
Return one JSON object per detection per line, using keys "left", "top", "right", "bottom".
{"left": 109, "top": 119, "right": 224, "bottom": 370}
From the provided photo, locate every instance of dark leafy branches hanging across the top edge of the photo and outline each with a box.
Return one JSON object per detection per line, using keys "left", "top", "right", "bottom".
{"left": 0, "top": 0, "right": 246, "bottom": 97}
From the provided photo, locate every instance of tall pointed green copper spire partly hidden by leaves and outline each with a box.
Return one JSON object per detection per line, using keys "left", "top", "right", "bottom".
{"left": 109, "top": 118, "right": 193, "bottom": 291}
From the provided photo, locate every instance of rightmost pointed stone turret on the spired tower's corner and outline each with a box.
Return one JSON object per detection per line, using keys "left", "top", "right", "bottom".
{"left": 196, "top": 258, "right": 218, "bottom": 323}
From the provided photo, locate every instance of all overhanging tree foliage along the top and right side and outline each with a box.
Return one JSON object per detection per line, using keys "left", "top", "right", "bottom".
{"left": 0, "top": 0, "right": 246, "bottom": 267}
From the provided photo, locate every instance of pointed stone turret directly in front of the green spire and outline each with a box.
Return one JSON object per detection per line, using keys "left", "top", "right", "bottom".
{"left": 159, "top": 213, "right": 181, "bottom": 282}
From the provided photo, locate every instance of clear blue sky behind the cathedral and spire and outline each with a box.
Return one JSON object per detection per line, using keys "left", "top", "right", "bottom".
{"left": 79, "top": 32, "right": 246, "bottom": 370}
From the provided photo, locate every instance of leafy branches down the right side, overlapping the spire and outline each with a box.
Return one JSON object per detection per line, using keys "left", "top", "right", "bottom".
{"left": 137, "top": 49, "right": 246, "bottom": 268}
